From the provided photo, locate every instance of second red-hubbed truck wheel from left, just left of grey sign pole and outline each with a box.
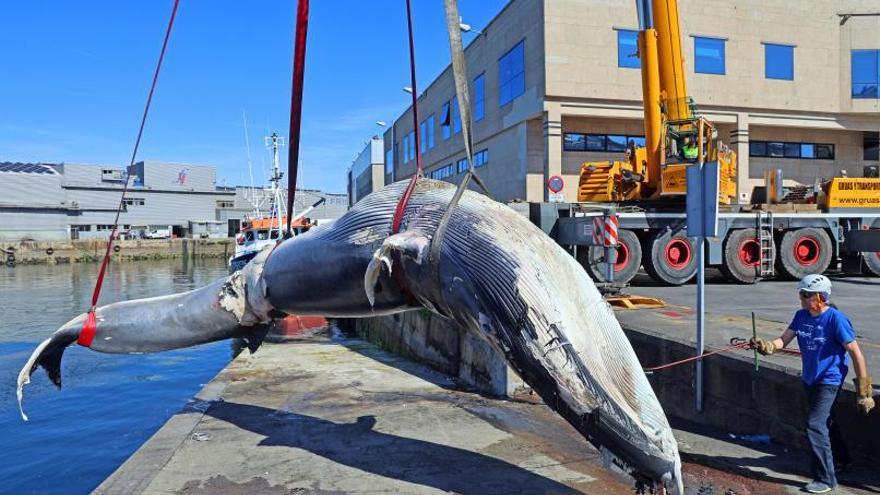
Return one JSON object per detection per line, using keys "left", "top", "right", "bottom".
{"left": 642, "top": 229, "right": 697, "bottom": 285}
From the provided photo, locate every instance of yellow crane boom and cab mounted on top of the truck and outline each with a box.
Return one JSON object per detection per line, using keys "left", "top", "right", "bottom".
{"left": 578, "top": 0, "right": 736, "bottom": 204}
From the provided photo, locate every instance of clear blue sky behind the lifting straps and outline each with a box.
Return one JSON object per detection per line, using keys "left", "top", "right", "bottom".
{"left": 0, "top": 0, "right": 507, "bottom": 192}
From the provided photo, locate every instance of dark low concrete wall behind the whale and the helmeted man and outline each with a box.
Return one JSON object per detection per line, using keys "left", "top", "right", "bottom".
{"left": 343, "top": 310, "right": 880, "bottom": 459}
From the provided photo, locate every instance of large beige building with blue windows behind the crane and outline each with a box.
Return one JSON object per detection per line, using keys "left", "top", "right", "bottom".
{"left": 375, "top": 0, "right": 880, "bottom": 202}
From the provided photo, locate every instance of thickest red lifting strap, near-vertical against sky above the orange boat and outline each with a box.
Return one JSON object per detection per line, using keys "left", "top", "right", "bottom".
{"left": 287, "top": 0, "right": 309, "bottom": 233}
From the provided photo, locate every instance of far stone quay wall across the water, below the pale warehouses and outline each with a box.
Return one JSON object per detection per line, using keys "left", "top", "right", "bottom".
{"left": 0, "top": 238, "right": 235, "bottom": 265}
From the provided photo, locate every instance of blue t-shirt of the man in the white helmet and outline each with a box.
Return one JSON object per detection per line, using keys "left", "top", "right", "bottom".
{"left": 789, "top": 308, "right": 856, "bottom": 385}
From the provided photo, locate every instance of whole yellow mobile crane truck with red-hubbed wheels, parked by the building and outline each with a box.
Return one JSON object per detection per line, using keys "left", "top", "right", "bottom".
{"left": 530, "top": 0, "right": 880, "bottom": 285}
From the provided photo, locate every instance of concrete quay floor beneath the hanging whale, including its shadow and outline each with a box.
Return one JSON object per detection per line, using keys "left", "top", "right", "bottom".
{"left": 96, "top": 333, "right": 876, "bottom": 495}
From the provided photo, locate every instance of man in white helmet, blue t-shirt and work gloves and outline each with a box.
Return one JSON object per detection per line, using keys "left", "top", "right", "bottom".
{"left": 750, "top": 274, "right": 874, "bottom": 493}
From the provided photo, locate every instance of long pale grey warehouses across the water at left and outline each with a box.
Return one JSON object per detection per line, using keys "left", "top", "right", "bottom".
{"left": 0, "top": 161, "right": 348, "bottom": 241}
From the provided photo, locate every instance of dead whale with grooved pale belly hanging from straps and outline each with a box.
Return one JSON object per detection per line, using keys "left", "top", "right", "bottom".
{"left": 17, "top": 178, "right": 683, "bottom": 493}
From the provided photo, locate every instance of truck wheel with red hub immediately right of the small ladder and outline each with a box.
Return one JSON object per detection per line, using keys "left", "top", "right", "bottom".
{"left": 776, "top": 227, "right": 832, "bottom": 280}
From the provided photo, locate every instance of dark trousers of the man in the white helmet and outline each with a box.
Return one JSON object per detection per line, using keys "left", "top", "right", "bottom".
{"left": 804, "top": 384, "right": 850, "bottom": 487}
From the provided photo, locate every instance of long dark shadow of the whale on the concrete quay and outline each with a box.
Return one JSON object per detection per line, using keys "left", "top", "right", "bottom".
{"left": 205, "top": 402, "right": 579, "bottom": 494}
